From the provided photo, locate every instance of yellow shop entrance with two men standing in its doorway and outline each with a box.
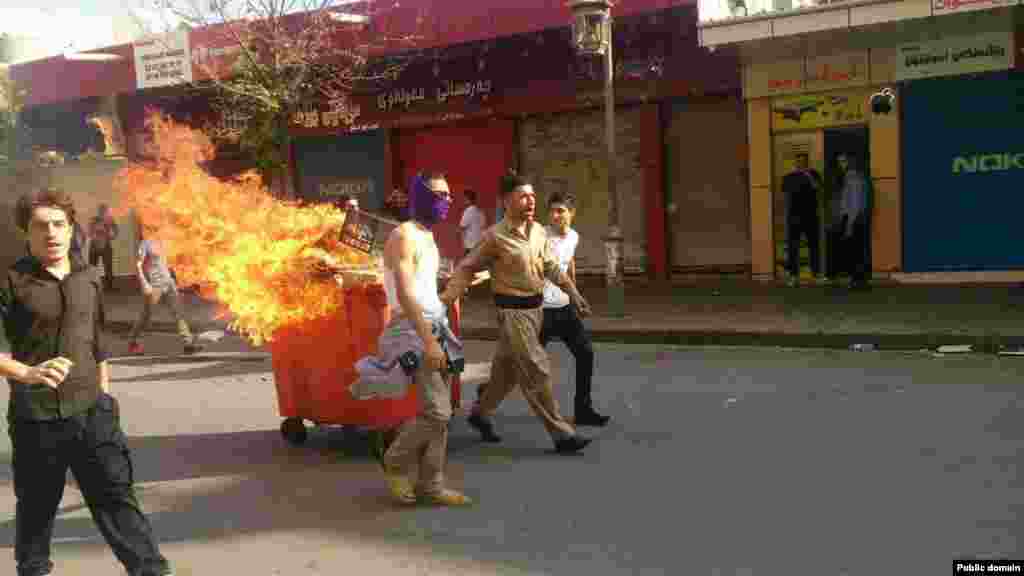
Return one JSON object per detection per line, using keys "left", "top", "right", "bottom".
{"left": 744, "top": 50, "right": 901, "bottom": 278}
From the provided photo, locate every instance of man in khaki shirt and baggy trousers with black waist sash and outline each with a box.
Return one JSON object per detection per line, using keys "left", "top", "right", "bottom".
{"left": 441, "top": 173, "right": 591, "bottom": 454}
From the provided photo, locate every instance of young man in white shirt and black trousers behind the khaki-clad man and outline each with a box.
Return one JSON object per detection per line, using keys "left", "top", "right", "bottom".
{"left": 541, "top": 193, "right": 610, "bottom": 426}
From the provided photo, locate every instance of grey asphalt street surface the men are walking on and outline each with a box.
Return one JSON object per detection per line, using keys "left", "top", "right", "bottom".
{"left": 0, "top": 334, "right": 1024, "bottom": 576}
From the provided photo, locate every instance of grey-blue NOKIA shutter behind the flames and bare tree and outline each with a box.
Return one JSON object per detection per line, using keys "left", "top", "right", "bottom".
{"left": 294, "top": 130, "right": 386, "bottom": 211}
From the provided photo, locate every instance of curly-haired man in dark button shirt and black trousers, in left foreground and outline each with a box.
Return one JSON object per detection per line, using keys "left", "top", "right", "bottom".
{"left": 0, "top": 189, "right": 171, "bottom": 576}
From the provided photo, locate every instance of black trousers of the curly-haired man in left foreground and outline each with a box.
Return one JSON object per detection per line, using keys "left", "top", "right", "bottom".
{"left": 8, "top": 395, "right": 170, "bottom": 576}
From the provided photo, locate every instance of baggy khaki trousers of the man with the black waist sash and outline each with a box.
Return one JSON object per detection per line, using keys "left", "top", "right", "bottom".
{"left": 476, "top": 308, "right": 575, "bottom": 442}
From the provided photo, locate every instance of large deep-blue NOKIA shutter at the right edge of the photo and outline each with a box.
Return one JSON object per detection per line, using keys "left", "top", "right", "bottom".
{"left": 902, "top": 72, "right": 1024, "bottom": 273}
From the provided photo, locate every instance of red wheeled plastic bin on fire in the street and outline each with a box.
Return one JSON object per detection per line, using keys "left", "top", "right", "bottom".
{"left": 270, "top": 284, "right": 461, "bottom": 444}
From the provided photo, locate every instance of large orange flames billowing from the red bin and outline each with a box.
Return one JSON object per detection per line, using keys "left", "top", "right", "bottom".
{"left": 115, "top": 114, "right": 375, "bottom": 344}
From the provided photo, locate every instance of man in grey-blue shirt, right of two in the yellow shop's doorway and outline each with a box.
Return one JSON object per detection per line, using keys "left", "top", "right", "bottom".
{"left": 838, "top": 154, "right": 870, "bottom": 290}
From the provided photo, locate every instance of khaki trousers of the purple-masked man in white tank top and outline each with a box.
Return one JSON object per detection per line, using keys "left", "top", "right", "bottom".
{"left": 383, "top": 360, "right": 452, "bottom": 495}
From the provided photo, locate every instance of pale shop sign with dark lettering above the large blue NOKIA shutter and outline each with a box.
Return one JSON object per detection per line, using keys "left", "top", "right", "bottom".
{"left": 893, "top": 32, "right": 1014, "bottom": 80}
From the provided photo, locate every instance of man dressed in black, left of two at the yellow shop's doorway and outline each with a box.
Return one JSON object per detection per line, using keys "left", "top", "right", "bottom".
{"left": 782, "top": 152, "right": 821, "bottom": 286}
